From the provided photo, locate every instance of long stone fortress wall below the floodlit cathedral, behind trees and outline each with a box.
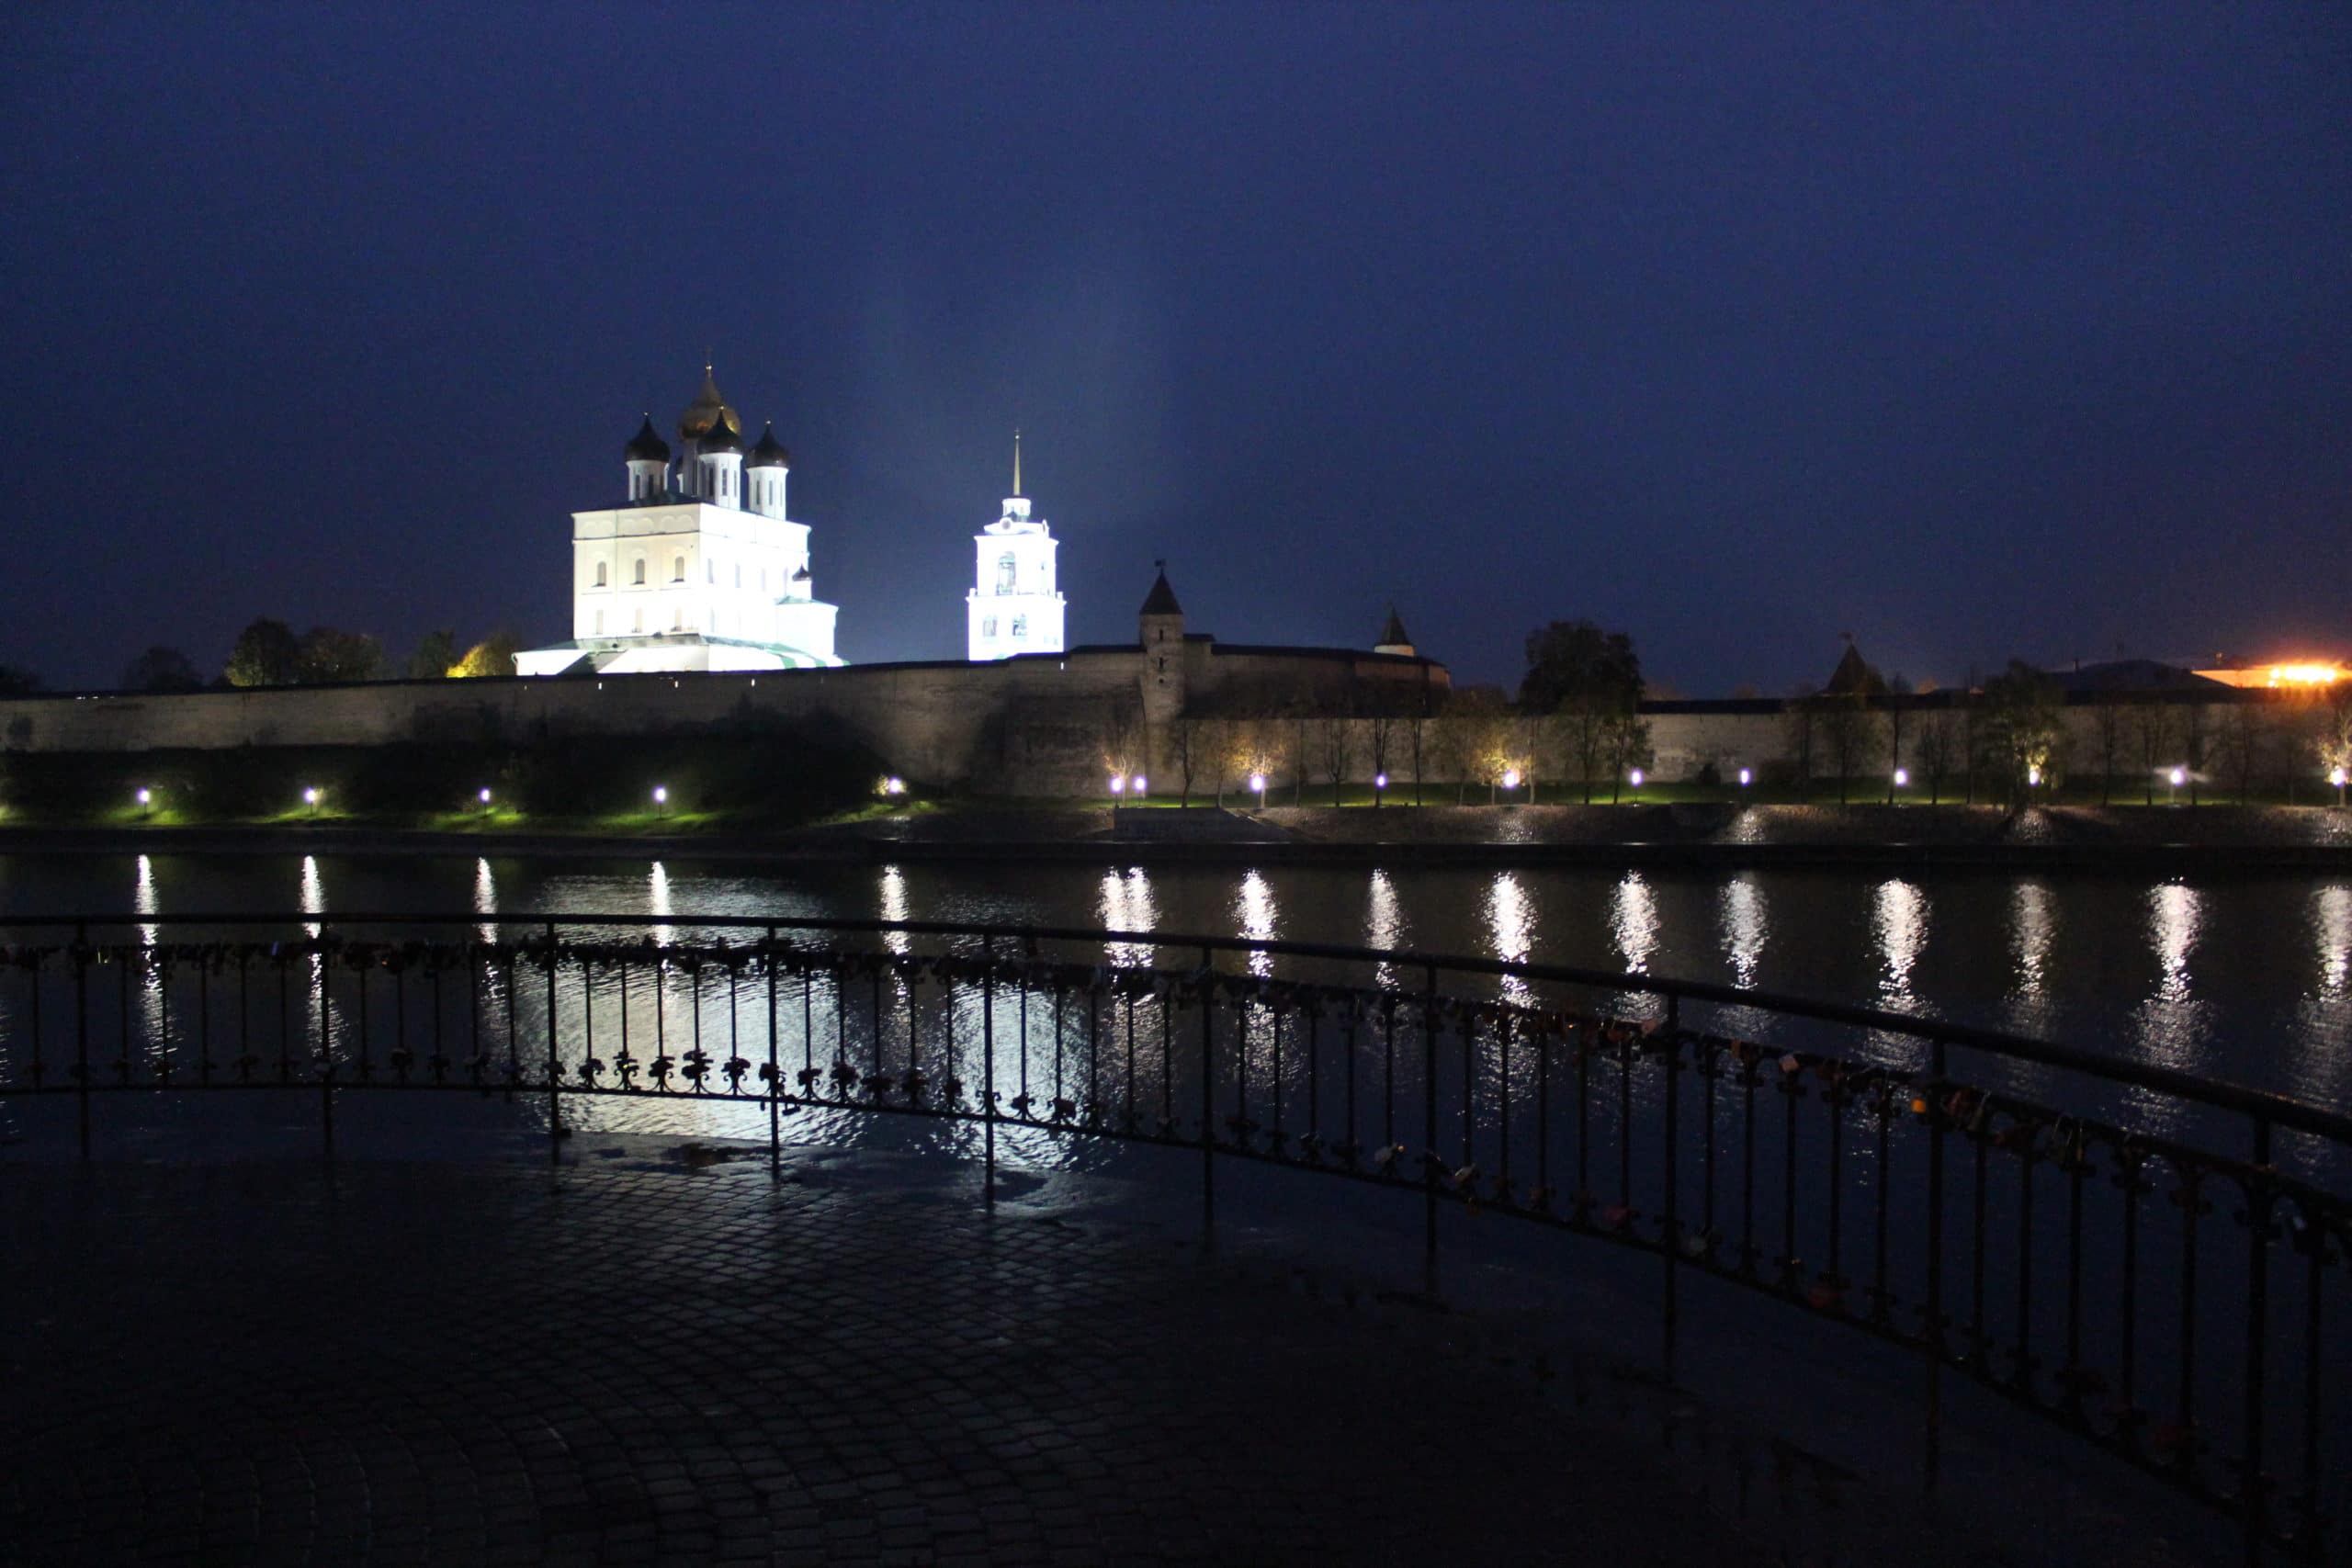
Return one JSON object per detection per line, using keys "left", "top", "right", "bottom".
{"left": 0, "top": 667, "right": 2328, "bottom": 799}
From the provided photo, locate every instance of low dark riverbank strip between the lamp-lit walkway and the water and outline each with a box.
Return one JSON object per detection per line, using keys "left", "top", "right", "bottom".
{"left": 0, "top": 804, "right": 2352, "bottom": 874}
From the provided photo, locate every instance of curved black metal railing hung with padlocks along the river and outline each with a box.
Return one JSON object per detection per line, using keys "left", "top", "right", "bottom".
{"left": 0, "top": 912, "right": 2352, "bottom": 1561}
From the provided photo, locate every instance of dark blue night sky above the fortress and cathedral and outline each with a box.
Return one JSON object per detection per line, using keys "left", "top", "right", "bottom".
{"left": 0, "top": 3, "right": 2352, "bottom": 694}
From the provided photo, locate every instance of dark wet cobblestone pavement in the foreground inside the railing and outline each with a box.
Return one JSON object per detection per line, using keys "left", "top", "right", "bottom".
{"left": 0, "top": 1159, "right": 1764, "bottom": 1563}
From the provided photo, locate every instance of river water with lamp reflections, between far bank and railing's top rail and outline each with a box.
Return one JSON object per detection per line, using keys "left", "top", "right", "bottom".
{"left": 0, "top": 856, "right": 2352, "bottom": 1110}
